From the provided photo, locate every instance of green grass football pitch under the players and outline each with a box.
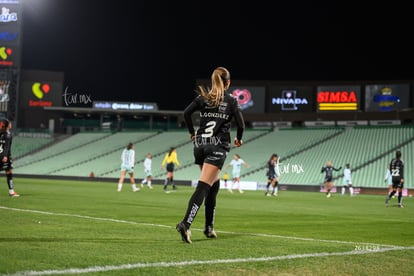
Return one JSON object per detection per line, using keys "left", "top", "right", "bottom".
{"left": 0, "top": 178, "right": 414, "bottom": 275}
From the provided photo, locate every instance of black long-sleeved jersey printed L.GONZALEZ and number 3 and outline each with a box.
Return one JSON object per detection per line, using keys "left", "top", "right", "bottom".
{"left": 184, "top": 93, "right": 245, "bottom": 150}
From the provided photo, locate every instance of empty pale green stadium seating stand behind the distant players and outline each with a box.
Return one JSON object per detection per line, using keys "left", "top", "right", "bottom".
{"left": 15, "top": 125, "right": 414, "bottom": 191}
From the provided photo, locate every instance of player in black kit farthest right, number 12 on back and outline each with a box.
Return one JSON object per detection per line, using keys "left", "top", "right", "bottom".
{"left": 385, "top": 150, "right": 404, "bottom": 208}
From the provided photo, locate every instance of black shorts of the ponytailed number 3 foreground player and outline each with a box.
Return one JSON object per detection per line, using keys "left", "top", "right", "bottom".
{"left": 194, "top": 144, "right": 228, "bottom": 170}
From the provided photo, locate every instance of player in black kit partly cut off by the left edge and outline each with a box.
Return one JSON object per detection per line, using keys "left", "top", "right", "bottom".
{"left": 0, "top": 119, "right": 20, "bottom": 197}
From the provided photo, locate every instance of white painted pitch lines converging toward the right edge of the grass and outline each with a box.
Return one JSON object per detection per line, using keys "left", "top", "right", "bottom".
{"left": 0, "top": 206, "right": 414, "bottom": 276}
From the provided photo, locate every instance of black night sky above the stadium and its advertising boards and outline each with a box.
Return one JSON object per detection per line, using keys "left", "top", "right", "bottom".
{"left": 22, "top": 0, "right": 414, "bottom": 110}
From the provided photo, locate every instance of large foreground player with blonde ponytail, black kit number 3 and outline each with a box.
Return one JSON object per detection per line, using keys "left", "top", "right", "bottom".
{"left": 176, "top": 67, "right": 245, "bottom": 243}
